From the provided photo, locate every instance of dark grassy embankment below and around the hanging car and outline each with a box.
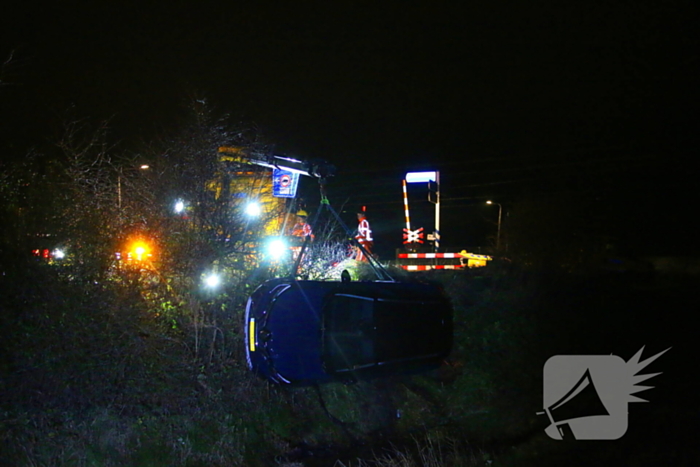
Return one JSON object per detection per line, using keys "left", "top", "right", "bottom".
{"left": 0, "top": 258, "right": 698, "bottom": 466}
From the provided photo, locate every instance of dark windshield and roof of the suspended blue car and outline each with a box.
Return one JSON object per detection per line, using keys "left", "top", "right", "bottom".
{"left": 324, "top": 294, "right": 450, "bottom": 372}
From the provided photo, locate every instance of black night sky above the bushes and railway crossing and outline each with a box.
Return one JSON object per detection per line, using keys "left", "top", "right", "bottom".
{"left": 0, "top": 0, "right": 700, "bottom": 254}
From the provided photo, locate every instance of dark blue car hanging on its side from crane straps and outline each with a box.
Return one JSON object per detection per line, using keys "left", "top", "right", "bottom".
{"left": 245, "top": 279, "right": 452, "bottom": 384}
